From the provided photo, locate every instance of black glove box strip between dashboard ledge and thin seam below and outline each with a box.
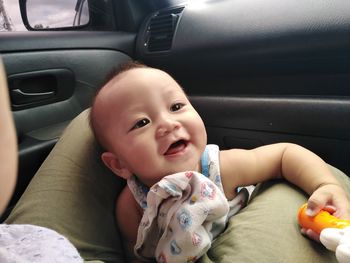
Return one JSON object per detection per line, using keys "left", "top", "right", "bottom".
{"left": 191, "top": 96, "right": 350, "bottom": 141}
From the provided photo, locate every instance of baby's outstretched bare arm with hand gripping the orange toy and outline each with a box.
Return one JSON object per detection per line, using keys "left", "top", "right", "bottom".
{"left": 220, "top": 143, "right": 350, "bottom": 219}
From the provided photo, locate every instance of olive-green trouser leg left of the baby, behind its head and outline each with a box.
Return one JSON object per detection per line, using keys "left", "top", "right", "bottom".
{"left": 5, "top": 111, "right": 124, "bottom": 262}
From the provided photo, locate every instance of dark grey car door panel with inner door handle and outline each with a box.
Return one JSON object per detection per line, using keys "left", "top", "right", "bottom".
{"left": 0, "top": 32, "right": 135, "bottom": 203}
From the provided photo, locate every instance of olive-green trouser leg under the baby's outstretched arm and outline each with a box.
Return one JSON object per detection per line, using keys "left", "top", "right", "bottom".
{"left": 201, "top": 167, "right": 350, "bottom": 263}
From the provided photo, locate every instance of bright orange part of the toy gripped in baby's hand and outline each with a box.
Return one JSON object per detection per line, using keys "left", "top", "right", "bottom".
{"left": 298, "top": 204, "right": 350, "bottom": 234}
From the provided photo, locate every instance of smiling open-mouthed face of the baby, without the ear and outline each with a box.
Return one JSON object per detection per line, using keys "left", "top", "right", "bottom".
{"left": 100, "top": 68, "right": 207, "bottom": 186}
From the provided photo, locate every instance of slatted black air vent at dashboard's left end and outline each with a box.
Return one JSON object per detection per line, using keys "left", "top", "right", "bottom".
{"left": 145, "top": 7, "right": 184, "bottom": 52}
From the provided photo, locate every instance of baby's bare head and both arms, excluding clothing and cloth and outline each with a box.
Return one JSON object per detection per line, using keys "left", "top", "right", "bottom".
{"left": 90, "top": 63, "right": 350, "bottom": 262}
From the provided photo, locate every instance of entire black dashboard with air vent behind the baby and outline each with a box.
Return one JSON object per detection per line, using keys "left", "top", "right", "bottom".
{"left": 136, "top": 0, "right": 350, "bottom": 177}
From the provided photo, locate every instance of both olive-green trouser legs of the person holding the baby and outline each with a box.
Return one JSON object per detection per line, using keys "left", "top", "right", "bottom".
{"left": 6, "top": 110, "right": 350, "bottom": 263}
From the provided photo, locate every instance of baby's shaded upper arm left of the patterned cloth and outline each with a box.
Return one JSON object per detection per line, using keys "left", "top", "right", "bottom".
{"left": 116, "top": 186, "right": 142, "bottom": 263}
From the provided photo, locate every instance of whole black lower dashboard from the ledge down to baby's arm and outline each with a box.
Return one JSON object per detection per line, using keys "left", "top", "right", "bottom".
{"left": 191, "top": 96, "right": 350, "bottom": 176}
